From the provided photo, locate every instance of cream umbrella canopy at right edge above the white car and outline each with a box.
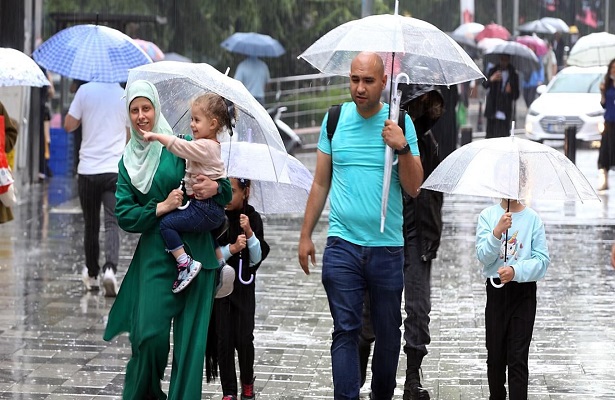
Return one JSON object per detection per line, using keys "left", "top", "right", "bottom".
{"left": 567, "top": 32, "right": 615, "bottom": 67}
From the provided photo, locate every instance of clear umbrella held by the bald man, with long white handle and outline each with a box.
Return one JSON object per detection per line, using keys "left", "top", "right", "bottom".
{"left": 299, "top": 1, "right": 485, "bottom": 231}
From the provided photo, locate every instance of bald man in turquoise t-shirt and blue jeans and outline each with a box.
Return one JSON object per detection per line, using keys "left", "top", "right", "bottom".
{"left": 299, "top": 52, "right": 423, "bottom": 400}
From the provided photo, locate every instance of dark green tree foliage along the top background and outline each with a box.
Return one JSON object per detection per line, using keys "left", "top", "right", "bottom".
{"left": 39, "top": 0, "right": 588, "bottom": 77}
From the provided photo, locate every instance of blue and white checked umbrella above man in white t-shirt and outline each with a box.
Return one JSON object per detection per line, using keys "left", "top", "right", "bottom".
{"left": 32, "top": 25, "right": 152, "bottom": 82}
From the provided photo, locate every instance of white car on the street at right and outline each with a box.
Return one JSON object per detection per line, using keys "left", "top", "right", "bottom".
{"left": 525, "top": 66, "right": 607, "bottom": 142}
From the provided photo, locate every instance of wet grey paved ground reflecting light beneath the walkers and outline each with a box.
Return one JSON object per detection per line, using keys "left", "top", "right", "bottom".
{"left": 0, "top": 142, "right": 615, "bottom": 400}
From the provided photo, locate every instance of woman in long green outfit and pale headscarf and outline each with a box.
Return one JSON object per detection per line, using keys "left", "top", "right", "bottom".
{"left": 103, "top": 81, "right": 231, "bottom": 400}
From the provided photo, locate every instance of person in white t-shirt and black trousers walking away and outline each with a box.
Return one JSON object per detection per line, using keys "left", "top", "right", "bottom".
{"left": 64, "top": 82, "right": 128, "bottom": 297}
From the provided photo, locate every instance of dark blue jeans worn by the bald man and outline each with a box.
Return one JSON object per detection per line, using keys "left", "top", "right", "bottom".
{"left": 322, "top": 237, "right": 404, "bottom": 400}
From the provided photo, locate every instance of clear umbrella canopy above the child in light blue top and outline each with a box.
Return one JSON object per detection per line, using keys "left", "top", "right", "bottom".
{"left": 421, "top": 136, "right": 599, "bottom": 202}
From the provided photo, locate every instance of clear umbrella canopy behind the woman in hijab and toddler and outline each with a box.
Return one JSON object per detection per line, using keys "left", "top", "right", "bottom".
{"left": 128, "top": 61, "right": 287, "bottom": 182}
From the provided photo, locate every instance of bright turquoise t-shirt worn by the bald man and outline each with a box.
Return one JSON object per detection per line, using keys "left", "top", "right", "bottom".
{"left": 318, "top": 102, "right": 419, "bottom": 247}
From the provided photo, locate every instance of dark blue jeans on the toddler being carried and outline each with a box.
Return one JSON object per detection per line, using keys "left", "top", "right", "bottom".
{"left": 160, "top": 199, "right": 224, "bottom": 252}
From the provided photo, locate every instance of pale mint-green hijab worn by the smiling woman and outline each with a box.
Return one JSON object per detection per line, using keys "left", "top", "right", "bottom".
{"left": 124, "top": 80, "right": 173, "bottom": 193}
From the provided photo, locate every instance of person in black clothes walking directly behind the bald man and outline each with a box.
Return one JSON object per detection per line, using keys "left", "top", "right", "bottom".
{"left": 359, "top": 84, "right": 446, "bottom": 400}
